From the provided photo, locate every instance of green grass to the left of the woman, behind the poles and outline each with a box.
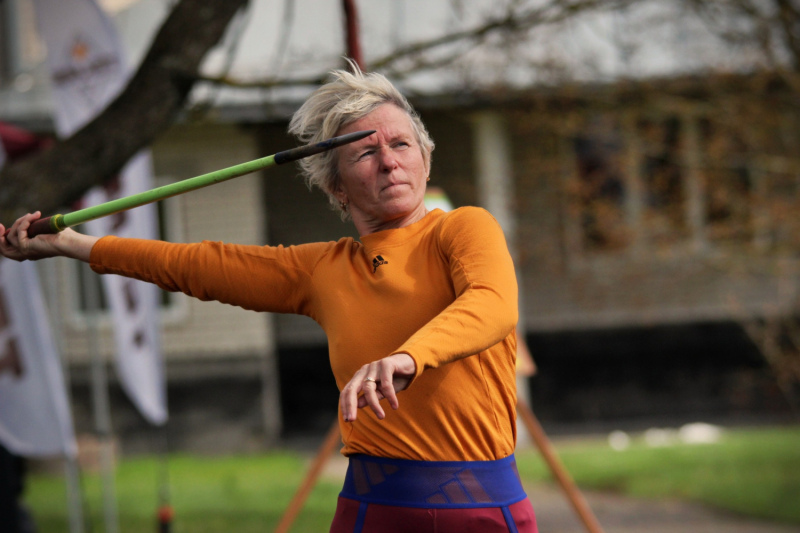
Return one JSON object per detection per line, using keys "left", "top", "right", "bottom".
{"left": 25, "top": 452, "right": 341, "bottom": 533}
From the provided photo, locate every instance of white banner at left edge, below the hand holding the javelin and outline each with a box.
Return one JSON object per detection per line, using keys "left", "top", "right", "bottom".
{"left": 0, "top": 259, "right": 77, "bottom": 457}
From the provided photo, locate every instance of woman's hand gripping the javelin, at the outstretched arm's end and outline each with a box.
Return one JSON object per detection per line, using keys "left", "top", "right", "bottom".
{"left": 0, "top": 211, "right": 97, "bottom": 262}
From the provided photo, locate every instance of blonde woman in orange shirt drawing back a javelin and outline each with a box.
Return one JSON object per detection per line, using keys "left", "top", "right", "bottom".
{"left": 0, "top": 64, "right": 536, "bottom": 533}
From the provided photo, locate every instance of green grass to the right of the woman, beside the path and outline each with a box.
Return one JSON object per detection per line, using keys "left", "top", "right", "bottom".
{"left": 517, "top": 428, "right": 800, "bottom": 524}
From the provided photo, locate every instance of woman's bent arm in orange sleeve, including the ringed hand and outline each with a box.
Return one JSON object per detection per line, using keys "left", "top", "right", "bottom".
{"left": 339, "top": 209, "right": 519, "bottom": 421}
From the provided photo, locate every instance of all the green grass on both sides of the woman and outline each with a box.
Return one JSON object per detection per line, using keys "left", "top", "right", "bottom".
{"left": 21, "top": 428, "right": 800, "bottom": 533}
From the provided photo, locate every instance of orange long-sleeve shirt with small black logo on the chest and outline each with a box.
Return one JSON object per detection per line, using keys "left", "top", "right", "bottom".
{"left": 91, "top": 207, "right": 517, "bottom": 461}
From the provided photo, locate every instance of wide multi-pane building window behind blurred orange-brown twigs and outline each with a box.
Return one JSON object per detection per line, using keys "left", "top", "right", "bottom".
{"left": 569, "top": 112, "right": 764, "bottom": 254}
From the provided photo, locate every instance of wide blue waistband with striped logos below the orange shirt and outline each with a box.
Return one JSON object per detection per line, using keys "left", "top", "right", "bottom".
{"left": 340, "top": 455, "right": 526, "bottom": 509}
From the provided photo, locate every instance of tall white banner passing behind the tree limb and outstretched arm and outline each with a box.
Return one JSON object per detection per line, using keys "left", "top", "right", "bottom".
{"left": 34, "top": 0, "right": 167, "bottom": 425}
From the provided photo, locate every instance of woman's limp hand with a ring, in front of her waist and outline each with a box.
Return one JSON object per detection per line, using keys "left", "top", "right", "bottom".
{"left": 339, "top": 353, "right": 417, "bottom": 422}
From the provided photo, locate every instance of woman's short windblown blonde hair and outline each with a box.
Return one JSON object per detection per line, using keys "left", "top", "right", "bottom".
{"left": 289, "top": 60, "right": 434, "bottom": 220}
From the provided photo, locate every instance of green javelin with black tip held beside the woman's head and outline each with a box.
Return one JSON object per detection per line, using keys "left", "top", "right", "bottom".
{"left": 13, "top": 130, "right": 375, "bottom": 239}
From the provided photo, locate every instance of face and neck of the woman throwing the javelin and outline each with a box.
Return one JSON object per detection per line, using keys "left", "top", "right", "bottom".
{"left": 335, "top": 104, "right": 429, "bottom": 235}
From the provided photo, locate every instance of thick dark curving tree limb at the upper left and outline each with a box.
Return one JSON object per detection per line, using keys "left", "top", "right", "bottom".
{"left": 0, "top": 0, "right": 247, "bottom": 221}
